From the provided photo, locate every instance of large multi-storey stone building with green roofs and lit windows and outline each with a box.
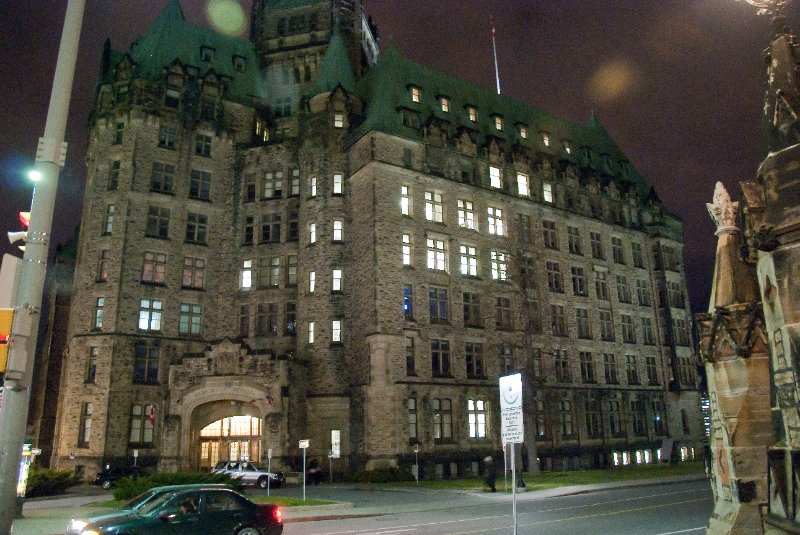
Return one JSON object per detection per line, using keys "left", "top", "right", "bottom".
{"left": 51, "top": 0, "right": 703, "bottom": 476}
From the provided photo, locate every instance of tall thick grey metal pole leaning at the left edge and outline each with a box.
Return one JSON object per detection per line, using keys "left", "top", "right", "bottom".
{"left": 0, "top": 0, "right": 85, "bottom": 534}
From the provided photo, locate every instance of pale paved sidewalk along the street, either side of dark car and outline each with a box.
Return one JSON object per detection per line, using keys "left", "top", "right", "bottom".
{"left": 12, "top": 474, "right": 706, "bottom": 535}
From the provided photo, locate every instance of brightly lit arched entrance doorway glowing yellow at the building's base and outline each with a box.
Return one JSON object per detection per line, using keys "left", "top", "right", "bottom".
{"left": 198, "top": 415, "right": 263, "bottom": 470}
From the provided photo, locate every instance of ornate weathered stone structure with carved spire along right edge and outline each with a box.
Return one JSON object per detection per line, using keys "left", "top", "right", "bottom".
{"left": 697, "top": 5, "right": 800, "bottom": 534}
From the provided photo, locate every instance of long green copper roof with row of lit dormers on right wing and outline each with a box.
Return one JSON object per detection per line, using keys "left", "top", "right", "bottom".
{"left": 354, "top": 45, "right": 651, "bottom": 198}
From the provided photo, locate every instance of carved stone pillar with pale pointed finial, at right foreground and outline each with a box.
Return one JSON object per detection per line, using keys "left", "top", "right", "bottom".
{"left": 697, "top": 182, "right": 772, "bottom": 535}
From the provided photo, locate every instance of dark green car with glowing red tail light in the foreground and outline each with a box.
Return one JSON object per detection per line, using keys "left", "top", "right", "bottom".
{"left": 68, "top": 485, "right": 283, "bottom": 535}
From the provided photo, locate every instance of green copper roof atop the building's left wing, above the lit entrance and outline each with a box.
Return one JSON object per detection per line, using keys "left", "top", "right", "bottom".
{"left": 123, "top": 0, "right": 263, "bottom": 103}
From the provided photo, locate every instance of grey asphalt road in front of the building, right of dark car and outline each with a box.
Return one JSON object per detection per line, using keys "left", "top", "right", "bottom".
{"left": 284, "top": 481, "right": 713, "bottom": 535}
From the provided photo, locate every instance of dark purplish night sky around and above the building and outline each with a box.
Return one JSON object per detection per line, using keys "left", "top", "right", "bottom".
{"left": 0, "top": 0, "right": 800, "bottom": 311}
